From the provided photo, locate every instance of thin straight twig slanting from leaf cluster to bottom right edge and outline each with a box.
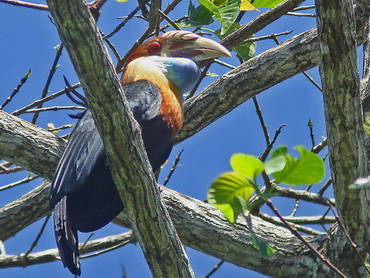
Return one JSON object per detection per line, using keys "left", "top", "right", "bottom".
{"left": 266, "top": 199, "right": 347, "bottom": 278}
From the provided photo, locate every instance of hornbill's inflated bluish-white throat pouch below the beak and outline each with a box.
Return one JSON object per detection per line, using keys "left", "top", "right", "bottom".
{"left": 151, "top": 56, "right": 200, "bottom": 93}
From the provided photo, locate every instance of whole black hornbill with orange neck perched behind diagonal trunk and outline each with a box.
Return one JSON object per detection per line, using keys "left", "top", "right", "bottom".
{"left": 49, "top": 30, "right": 231, "bottom": 276}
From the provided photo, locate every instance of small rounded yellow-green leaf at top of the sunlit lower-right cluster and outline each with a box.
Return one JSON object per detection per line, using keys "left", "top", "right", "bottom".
{"left": 230, "top": 153, "right": 265, "bottom": 180}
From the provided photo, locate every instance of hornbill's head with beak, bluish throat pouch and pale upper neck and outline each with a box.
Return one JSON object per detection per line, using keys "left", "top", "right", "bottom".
{"left": 122, "top": 31, "right": 231, "bottom": 95}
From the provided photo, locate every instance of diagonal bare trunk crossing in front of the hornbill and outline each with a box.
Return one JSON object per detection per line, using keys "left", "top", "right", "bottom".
{"left": 48, "top": 0, "right": 193, "bottom": 277}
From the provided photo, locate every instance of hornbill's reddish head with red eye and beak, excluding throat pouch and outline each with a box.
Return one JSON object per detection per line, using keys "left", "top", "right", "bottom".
{"left": 126, "top": 30, "right": 231, "bottom": 66}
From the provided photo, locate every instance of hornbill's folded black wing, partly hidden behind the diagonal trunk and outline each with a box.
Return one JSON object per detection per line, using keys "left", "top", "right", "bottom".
{"left": 50, "top": 81, "right": 162, "bottom": 208}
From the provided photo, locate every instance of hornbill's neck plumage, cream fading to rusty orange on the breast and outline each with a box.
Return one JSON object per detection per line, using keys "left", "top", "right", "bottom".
{"left": 122, "top": 57, "right": 183, "bottom": 136}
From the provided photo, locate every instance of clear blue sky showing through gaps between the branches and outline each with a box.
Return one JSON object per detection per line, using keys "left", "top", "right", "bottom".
{"left": 0, "top": 0, "right": 325, "bottom": 278}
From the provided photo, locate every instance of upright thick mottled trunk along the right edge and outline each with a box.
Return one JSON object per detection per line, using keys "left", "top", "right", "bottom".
{"left": 316, "top": 0, "right": 370, "bottom": 277}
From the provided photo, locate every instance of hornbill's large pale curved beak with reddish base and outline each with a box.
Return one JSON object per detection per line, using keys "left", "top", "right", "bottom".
{"left": 165, "top": 31, "right": 231, "bottom": 64}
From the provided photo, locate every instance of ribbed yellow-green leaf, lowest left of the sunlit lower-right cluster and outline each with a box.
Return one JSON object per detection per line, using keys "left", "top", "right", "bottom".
{"left": 207, "top": 172, "right": 254, "bottom": 223}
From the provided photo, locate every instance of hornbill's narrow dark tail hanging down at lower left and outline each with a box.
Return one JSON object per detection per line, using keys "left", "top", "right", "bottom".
{"left": 54, "top": 196, "right": 81, "bottom": 276}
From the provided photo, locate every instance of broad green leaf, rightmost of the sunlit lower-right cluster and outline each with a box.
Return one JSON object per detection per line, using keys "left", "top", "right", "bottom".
{"left": 273, "top": 146, "right": 325, "bottom": 185}
